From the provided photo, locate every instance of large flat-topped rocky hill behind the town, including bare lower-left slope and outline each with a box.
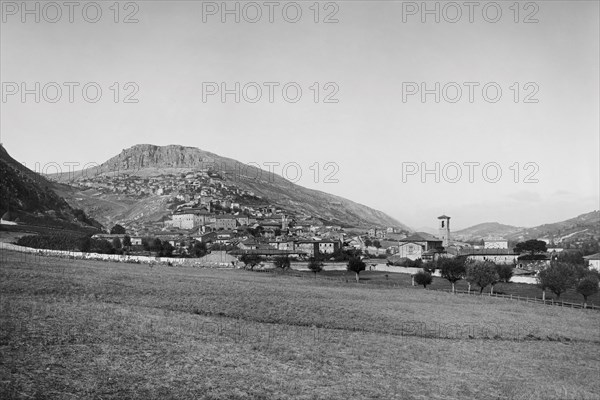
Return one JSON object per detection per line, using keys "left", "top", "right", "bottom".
{"left": 53, "top": 144, "right": 410, "bottom": 230}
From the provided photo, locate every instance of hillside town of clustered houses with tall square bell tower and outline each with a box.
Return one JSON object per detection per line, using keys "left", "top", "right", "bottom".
{"left": 84, "top": 206, "right": 600, "bottom": 276}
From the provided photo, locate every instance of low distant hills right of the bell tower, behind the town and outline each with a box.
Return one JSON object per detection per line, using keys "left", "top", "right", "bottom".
{"left": 452, "top": 211, "right": 600, "bottom": 244}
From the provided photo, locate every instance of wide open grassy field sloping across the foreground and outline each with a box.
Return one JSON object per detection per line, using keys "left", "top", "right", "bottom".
{"left": 0, "top": 252, "right": 600, "bottom": 400}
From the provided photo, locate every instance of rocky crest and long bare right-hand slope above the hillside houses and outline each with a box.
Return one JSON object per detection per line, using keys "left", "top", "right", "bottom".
{"left": 51, "top": 144, "right": 410, "bottom": 231}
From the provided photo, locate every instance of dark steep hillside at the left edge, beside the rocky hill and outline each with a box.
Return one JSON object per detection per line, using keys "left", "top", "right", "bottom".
{"left": 0, "top": 145, "right": 102, "bottom": 231}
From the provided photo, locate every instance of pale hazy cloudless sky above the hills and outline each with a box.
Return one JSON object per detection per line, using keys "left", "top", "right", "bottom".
{"left": 0, "top": 1, "right": 600, "bottom": 229}
